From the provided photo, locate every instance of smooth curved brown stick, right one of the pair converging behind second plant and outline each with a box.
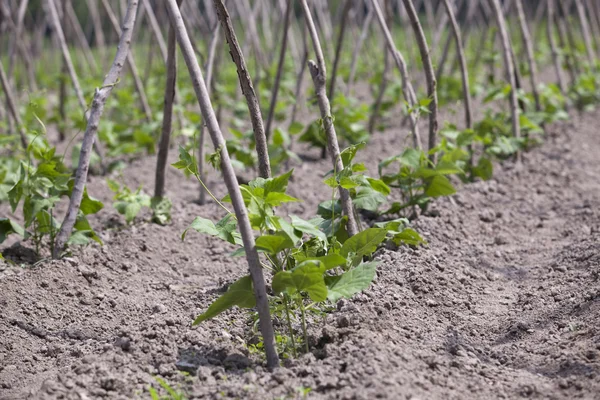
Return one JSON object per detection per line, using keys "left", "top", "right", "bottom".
{"left": 403, "top": 0, "right": 438, "bottom": 161}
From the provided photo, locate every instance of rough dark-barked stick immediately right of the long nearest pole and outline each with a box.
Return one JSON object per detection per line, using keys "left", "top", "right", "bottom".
{"left": 214, "top": 0, "right": 271, "bottom": 178}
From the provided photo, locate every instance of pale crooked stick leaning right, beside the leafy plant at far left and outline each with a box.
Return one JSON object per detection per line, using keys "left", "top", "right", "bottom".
{"left": 50, "top": 0, "right": 138, "bottom": 258}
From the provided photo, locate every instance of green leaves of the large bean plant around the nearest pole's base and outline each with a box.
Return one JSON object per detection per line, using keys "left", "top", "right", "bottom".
{"left": 182, "top": 159, "right": 423, "bottom": 355}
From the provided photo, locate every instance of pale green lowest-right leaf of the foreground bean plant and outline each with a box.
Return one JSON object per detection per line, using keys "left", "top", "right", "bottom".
{"left": 325, "top": 261, "right": 378, "bottom": 303}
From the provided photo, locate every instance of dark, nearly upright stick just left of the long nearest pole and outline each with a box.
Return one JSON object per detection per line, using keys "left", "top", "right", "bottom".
{"left": 152, "top": 0, "right": 182, "bottom": 198}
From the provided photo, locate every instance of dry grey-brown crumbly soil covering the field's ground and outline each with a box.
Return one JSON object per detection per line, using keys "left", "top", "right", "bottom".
{"left": 0, "top": 106, "right": 600, "bottom": 400}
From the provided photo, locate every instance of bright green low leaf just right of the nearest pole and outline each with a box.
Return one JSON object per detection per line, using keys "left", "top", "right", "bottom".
{"left": 271, "top": 261, "right": 327, "bottom": 302}
